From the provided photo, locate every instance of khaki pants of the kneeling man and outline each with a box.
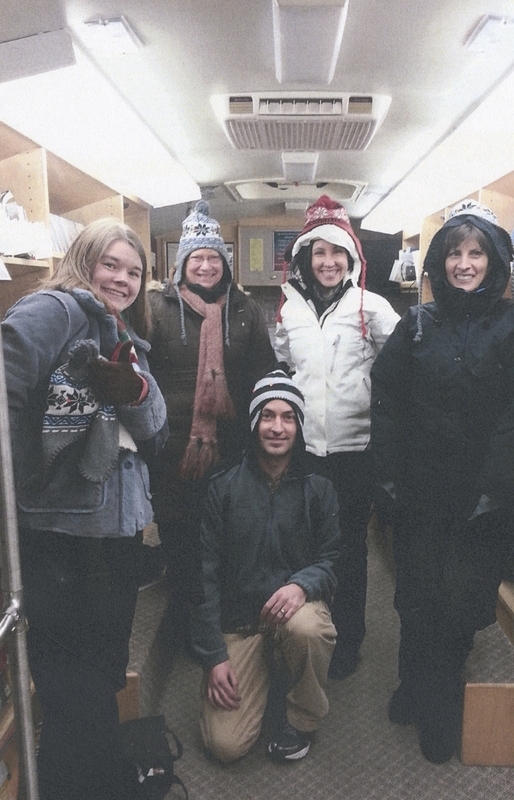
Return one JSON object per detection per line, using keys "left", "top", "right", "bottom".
{"left": 200, "top": 600, "right": 336, "bottom": 763}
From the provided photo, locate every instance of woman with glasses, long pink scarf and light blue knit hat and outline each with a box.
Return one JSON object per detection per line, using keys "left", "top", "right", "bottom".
{"left": 149, "top": 200, "right": 274, "bottom": 635}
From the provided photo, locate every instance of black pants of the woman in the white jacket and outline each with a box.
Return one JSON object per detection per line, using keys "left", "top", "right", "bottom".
{"left": 307, "top": 452, "right": 373, "bottom": 662}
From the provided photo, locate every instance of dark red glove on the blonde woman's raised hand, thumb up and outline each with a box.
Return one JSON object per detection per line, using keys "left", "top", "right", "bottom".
{"left": 89, "top": 341, "right": 145, "bottom": 406}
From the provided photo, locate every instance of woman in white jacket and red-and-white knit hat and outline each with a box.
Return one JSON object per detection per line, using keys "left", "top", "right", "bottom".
{"left": 275, "top": 195, "right": 399, "bottom": 680}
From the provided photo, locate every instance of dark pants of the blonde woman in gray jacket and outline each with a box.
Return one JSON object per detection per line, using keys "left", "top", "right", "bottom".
{"left": 20, "top": 530, "right": 142, "bottom": 800}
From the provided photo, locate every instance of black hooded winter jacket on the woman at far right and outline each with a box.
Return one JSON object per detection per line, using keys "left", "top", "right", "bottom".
{"left": 371, "top": 215, "right": 514, "bottom": 519}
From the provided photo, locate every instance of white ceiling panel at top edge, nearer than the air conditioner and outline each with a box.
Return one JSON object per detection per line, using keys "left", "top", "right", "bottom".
{"left": 271, "top": 0, "right": 348, "bottom": 85}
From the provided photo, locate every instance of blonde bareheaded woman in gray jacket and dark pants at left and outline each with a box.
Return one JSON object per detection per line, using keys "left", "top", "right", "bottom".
{"left": 2, "top": 219, "right": 167, "bottom": 800}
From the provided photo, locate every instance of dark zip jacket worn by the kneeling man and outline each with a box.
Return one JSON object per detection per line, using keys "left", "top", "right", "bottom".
{"left": 192, "top": 457, "right": 339, "bottom": 669}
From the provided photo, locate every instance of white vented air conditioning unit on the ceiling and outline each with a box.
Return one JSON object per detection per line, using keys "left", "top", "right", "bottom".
{"left": 211, "top": 92, "right": 391, "bottom": 151}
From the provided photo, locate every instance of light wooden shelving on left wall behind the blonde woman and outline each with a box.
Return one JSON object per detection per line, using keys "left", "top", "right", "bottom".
{"left": 0, "top": 122, "right": 151, "bottom": 316}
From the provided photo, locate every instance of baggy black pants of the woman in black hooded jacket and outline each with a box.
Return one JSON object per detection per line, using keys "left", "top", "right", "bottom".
{"left": 393, "top": 508, "right": 513, "bottom": 687}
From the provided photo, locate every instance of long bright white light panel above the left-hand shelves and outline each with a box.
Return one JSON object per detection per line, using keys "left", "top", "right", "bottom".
{"left": 0, "top": 45, "right": 201, "bottom": 208}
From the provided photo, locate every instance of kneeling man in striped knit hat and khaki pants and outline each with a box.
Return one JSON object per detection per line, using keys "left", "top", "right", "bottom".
{"left": 192, "top": 370, "right": 339, "bottom": 763}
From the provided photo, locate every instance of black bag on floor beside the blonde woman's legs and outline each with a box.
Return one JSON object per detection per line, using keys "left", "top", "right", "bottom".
{"left": 120, "top": 715, "right": 188, "bottom": 800}
